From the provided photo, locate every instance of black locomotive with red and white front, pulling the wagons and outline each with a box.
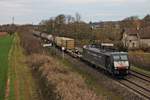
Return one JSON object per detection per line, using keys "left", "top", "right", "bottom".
{"left": 82, "top": 45, "right": 130, "bottom": 76}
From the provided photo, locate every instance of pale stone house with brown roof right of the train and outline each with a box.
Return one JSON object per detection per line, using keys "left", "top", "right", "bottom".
{"left": 122, "top": 27, "right": 150, "bottom": 49}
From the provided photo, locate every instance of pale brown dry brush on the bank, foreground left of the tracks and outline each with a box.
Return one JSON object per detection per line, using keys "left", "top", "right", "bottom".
{"left": 28, "top": 54, "right": 102, "bottom": 100}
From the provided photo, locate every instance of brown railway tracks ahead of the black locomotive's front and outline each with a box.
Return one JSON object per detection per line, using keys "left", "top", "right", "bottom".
{"left": 119, "top": 70, "right": 150, "bottom": 100}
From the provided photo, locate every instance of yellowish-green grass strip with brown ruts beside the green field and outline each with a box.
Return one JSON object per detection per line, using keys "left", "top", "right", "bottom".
{"left": 5, "top": 35, "right": 41, "bottom": 100}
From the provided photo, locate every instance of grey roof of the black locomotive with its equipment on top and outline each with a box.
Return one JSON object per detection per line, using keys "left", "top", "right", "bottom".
{"left": 86, "top": 47, "right": 128, "bottom": 56}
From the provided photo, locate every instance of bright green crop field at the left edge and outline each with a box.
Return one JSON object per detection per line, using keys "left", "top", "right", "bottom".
{"left": 0, "top": 36, "right": 13, "bottom": 100}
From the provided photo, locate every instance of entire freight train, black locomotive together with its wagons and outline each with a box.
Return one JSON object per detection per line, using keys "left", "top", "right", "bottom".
{"left": 33, "top": 32, "right": 130, "bottom": 77}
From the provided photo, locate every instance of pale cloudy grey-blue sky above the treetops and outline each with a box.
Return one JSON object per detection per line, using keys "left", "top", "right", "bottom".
{"left": 0, "top": 0, "right": 150, "bottom": 24}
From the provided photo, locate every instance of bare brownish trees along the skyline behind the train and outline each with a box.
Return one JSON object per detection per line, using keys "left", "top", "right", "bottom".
{"left": 39, "top": 13, "right": 150, "bottom": 47}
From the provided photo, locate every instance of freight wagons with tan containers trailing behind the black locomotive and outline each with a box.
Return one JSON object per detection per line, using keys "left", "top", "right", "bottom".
{"left": 33, "top": 31, "right": 82, "bottom": 58}
